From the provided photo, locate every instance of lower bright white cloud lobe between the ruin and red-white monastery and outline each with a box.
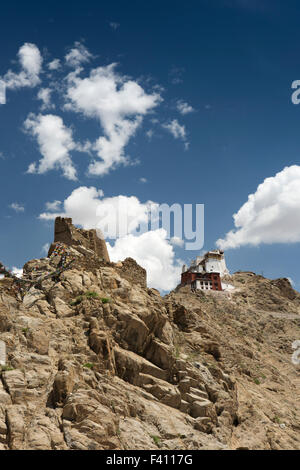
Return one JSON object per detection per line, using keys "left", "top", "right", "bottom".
{"left": 107, "top": 229, "right": 182, "bottom": 291}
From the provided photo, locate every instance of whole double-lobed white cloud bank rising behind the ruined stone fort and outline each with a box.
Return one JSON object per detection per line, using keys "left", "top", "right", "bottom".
{"left": 39, "top": 186, "right": 182, "bottom": 290}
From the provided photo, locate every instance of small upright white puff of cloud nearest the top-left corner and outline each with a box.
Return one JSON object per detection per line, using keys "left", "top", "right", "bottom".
{"left": 3, "top": 42, "right": 43, "bottom": 89}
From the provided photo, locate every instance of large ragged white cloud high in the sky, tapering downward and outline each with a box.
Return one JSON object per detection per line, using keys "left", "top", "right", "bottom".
{"left": 67, "top": 64, "right": 161, "bottom": 175}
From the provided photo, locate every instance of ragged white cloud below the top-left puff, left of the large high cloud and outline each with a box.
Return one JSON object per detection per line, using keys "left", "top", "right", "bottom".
{"left": 24, "top": 114, "right": 77, "bottom": 180}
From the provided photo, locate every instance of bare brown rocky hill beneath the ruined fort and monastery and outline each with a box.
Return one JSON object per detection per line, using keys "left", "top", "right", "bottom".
{"left": 0, "top": 222, "right": 300, "bottom": 450}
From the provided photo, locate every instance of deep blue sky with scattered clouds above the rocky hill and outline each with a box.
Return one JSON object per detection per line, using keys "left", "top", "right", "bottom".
{"left": 0, "top": 0, "right": 300, "bottom": 290}
